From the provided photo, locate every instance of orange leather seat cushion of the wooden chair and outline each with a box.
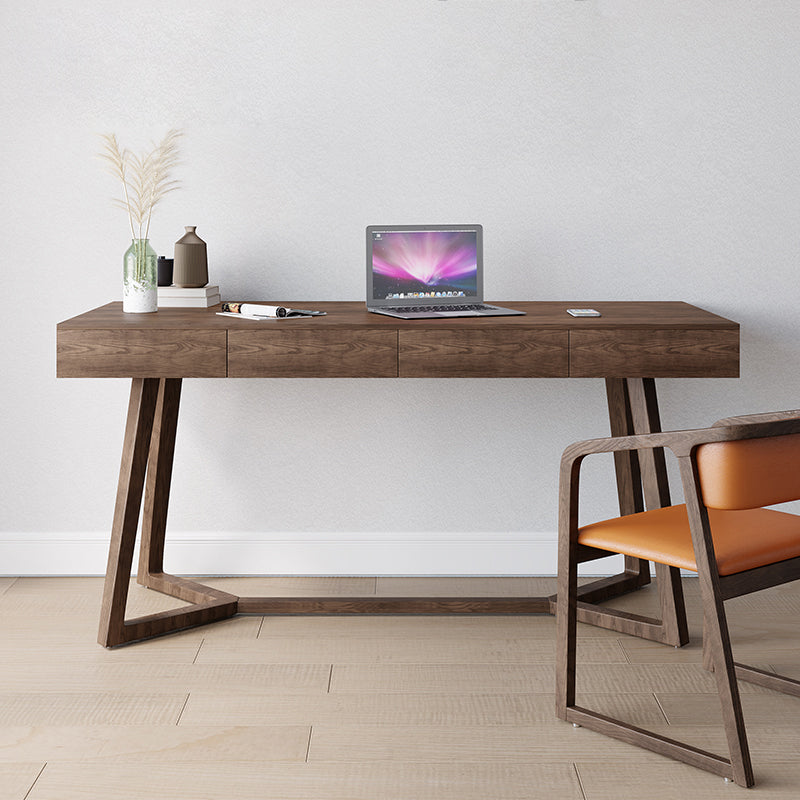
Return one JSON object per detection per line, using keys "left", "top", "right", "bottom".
{"left": 578, "top": 505, "right": 800, "bottom": 575}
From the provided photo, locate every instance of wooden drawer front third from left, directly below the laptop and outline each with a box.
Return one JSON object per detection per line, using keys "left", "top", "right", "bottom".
{"left": 398, "top": 329, "right": 569, "bottom": 378}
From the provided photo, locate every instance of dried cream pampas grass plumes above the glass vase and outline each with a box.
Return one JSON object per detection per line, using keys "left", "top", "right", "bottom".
{"left": 99, "top": 128, "right": 183, "bottom": 239}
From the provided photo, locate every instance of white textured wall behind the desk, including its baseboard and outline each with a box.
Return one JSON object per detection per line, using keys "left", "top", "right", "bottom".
{"left": 0, "top": 0, "right": 800, "bottom": 574}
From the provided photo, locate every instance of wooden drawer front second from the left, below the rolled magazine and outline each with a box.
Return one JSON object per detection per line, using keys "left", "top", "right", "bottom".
{"left": 228, "top": 321, "right": 397, "bottom": 378}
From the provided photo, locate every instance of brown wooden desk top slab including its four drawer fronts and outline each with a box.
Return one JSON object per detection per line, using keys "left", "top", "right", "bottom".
{"left": 56, "top": 301, "right": 739, "bottom": 378}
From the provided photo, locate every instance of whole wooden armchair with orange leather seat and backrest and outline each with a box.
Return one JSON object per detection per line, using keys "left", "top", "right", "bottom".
{"left": 556, "top": 410, "right": 800, "bottom": 786}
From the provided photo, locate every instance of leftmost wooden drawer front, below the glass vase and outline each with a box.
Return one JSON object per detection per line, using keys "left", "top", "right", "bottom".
{"left": 56, "top": 329, "right": 227, "bottom": 378}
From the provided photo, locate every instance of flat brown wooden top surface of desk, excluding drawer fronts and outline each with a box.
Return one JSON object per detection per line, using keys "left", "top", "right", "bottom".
{"left": 58, "top": 300, "right": 739, "bottom": 330}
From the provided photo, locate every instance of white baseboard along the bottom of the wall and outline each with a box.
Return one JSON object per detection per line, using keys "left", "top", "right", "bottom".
{"left": 0, "top": 531, "right": 622, "bottom": 576}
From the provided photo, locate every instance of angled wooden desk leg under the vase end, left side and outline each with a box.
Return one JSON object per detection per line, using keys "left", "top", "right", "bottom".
{"left": 98, "top": 378, "right": 238, "bottom": 647}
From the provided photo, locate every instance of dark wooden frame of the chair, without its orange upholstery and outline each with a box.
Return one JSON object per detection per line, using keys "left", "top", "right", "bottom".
{"left": 556, "top": 410, "right": 800, "bottom": 786}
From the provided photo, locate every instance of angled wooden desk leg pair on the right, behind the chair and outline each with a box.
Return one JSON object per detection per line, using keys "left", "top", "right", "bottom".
{"left": 560, "top": 378, "right": 689, "bottom": 647}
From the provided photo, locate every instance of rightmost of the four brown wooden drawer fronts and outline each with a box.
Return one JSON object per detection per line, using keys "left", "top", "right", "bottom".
{"left": 569, "top": 328, "right": 739, "bottom": 378}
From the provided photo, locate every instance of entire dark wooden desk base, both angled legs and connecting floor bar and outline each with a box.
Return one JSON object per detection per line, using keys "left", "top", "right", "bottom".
{"left": 99, "top": 378, "right": 688, "bottom": 647}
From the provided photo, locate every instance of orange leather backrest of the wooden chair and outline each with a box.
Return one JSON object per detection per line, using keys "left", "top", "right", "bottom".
{"left": 697, "top": 433, "right": 800, "bottom": 510}
